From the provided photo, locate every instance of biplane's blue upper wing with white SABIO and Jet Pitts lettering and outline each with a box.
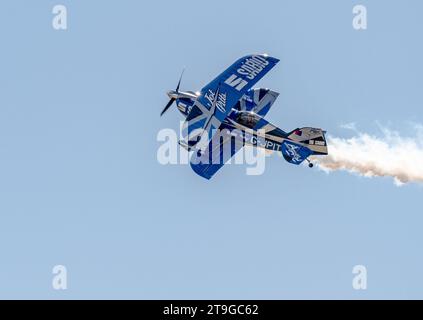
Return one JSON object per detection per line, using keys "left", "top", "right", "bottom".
{"left": 182, "top": 54, "right": 279, "bottom": 152}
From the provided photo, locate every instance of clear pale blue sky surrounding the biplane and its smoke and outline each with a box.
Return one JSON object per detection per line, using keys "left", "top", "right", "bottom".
{"left": 0, "top": 0, "right": 423, "bottom": 299}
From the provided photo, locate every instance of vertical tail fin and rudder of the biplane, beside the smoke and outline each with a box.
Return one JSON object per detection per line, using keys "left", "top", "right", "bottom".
{"left": 288, "top": 127, "right": 328, "bottom": 155}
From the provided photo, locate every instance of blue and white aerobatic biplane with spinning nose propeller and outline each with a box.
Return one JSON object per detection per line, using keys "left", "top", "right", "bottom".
{"left": 161, "top": 54, "right": 328, "bottom": 179}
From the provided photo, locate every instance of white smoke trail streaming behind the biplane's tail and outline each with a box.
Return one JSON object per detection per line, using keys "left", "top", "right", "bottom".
{"left": 314, "top": 125, "right": 423, "bottom": 186}
